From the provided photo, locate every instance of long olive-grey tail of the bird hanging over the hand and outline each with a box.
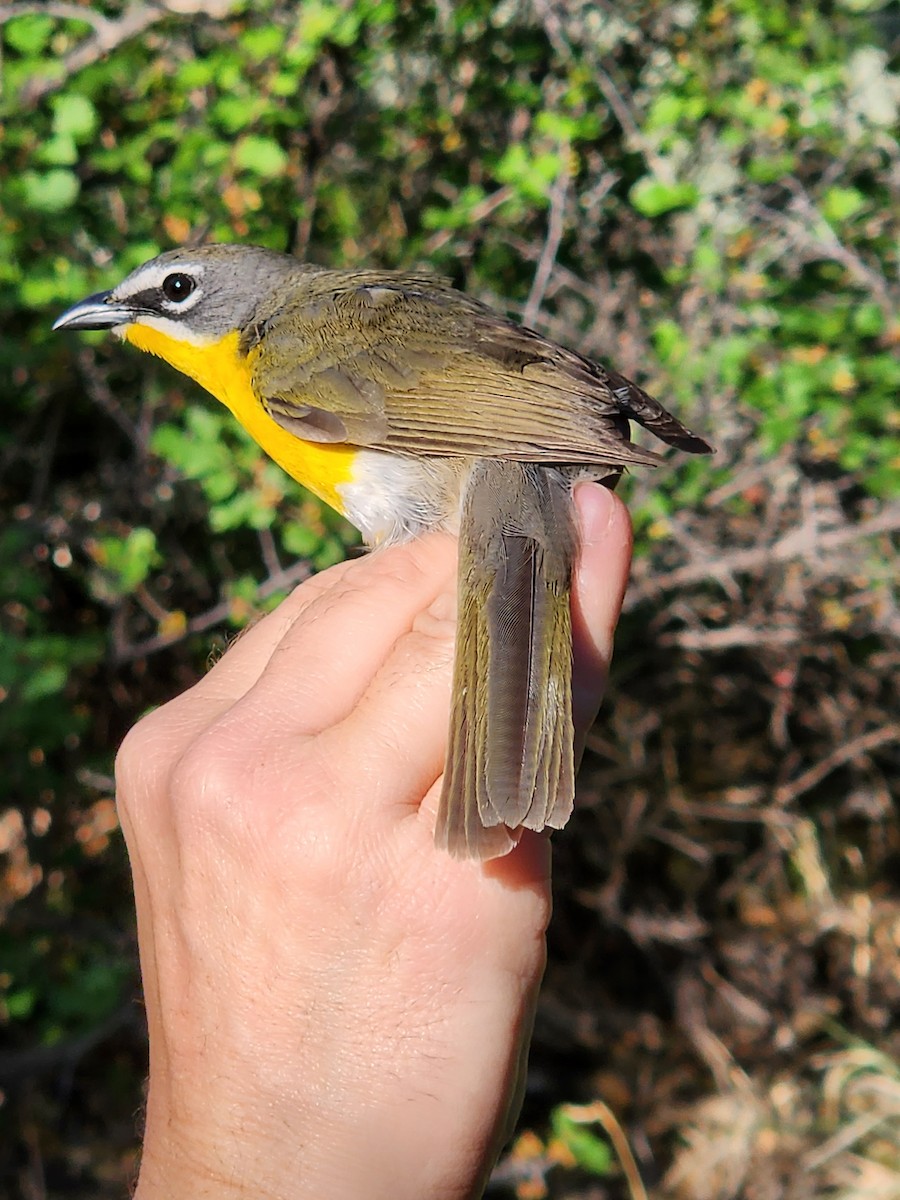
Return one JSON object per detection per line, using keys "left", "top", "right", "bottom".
{"left": 436, "top": 460, "right": 575, "bottom": 858}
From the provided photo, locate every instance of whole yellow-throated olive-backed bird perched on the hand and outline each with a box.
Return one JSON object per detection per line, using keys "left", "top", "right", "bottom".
{"left": 53, "top": 245, "right": 712, "bottom": 858}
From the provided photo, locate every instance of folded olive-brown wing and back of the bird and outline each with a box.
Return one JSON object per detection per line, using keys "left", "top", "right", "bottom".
{"left": 246, "top": 271, "right": 708, "bottom": 464}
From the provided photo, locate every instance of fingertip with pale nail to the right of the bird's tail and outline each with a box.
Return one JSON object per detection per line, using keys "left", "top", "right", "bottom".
{"left": 572, "top": 484, "right": 631, "bottom": 731}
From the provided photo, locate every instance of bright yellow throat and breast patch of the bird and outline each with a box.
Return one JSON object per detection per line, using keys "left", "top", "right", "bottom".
{"left": 124, "top": 324, "right": 358, "bottom": 514}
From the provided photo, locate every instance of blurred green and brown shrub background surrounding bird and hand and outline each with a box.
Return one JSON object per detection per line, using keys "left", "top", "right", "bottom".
{"left": 0, "top": 0, "right": 900, "bottom": 1200}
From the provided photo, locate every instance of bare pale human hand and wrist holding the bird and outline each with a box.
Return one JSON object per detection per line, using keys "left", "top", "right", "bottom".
{"left": 116, "top": 485, "right": 631, "bottom": 1200}
